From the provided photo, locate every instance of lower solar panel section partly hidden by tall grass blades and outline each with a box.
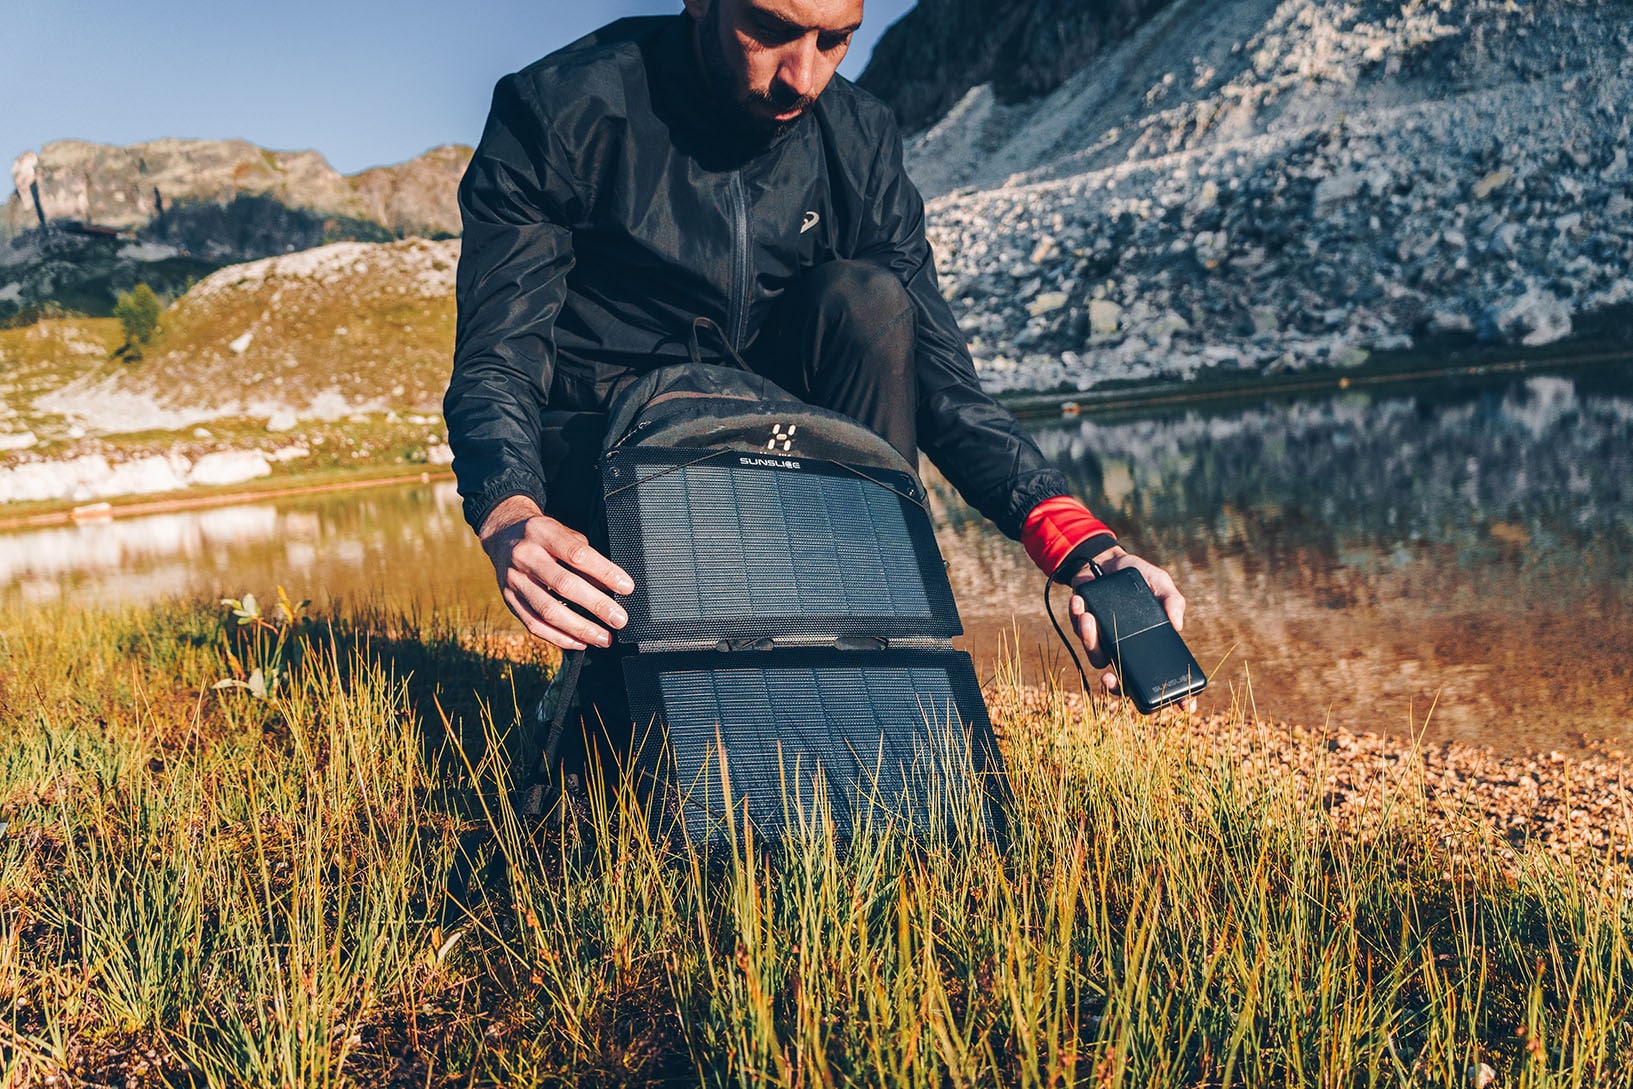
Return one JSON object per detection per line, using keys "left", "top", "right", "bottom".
{"left": 624, "top": 648, "right": 1003, "bottom": 842}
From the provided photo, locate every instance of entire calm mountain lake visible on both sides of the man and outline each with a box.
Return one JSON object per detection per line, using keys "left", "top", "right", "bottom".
{"left": 0, "top": 366, "right": 1633, "bottom": 751}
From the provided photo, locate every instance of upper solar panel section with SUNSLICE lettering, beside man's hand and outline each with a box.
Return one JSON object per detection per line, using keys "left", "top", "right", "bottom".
{"left": 603, "top": 447, "right": 963, "bottom": 645}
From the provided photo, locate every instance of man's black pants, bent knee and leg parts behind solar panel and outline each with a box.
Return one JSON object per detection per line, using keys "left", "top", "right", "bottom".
{"left": 547, "top": 261, "right": 918, "bottom": 776}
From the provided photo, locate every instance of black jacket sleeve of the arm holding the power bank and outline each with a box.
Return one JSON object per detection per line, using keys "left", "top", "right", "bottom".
{"left": 856, "top": 115, "right": 1068, "bottom": 540}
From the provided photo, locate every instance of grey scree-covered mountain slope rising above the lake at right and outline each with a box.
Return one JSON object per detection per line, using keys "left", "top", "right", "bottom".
{"left": 908, "top": 0, "right": 1633, "bottom": 390}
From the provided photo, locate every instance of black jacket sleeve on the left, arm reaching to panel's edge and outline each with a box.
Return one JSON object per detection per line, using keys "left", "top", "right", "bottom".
{"left": 443, "top": 75, "right": 581, "bottom": 529}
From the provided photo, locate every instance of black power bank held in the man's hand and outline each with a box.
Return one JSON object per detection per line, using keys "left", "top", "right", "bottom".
{"left": 1076, "top": 567, "right": 1208, "bottom": 715}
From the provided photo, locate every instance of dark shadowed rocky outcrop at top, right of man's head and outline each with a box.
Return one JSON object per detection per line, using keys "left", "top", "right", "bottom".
{"left": 857, "top": 0, "right": 1169, "bottom": 132}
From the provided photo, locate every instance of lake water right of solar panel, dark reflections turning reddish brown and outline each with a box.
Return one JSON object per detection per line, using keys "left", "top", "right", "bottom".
{"left": 939, "top": 371, "right": 1633, "bottom": 748}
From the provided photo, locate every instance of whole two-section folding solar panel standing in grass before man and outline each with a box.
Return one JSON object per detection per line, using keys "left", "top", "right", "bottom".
{"left": 601, "top": 421, "right": 1006, "bottom": 842}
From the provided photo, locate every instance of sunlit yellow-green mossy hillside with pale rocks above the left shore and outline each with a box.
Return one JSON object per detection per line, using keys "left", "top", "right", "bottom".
{"left": 0, "top": 242, "right": 459, "bottom": 499}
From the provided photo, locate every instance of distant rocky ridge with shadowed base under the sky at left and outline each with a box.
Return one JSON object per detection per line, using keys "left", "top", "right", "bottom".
{"left": 0, "top": 140, "right": 470, "bottom": 318}
